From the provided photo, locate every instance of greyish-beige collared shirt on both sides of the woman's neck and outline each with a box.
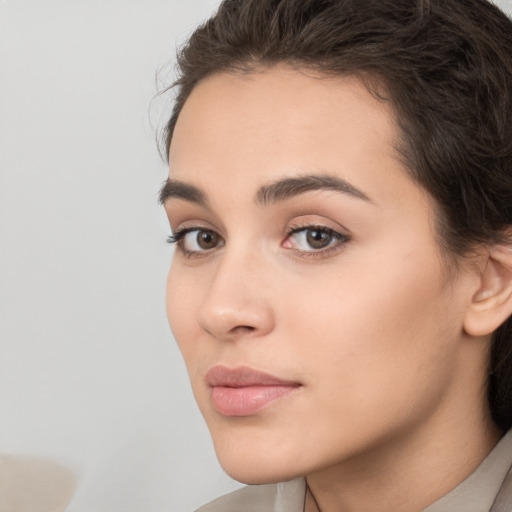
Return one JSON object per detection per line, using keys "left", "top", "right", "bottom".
{"left": 196, "top": 430, "right": 512, "bottom": 512}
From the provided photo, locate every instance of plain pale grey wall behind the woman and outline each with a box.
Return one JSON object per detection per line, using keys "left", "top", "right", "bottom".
{"left": 0, "top": 0, "right": 512, "bottom": 512}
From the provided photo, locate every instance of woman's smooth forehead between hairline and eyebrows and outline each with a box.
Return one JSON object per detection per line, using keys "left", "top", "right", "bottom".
{"left": 169, "top": 65, "right": 403, "bottom": 204}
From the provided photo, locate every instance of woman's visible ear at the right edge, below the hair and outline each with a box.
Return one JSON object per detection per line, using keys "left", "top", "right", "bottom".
{"left": 464, "top": 243, "right": 512, "bottom": 336}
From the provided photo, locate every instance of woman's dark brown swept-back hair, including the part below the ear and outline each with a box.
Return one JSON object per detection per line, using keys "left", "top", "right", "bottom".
{"left": 164, "top": 0, "right": 512, "bottom": 430}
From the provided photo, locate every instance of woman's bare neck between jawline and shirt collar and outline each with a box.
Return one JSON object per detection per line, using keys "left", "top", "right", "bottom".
{"left": 305, "top": 416, "right": 502, "bottom": 512}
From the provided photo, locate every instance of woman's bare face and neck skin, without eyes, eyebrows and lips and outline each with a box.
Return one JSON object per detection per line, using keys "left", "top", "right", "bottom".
{"left": 164, "top": 66, "right": 500, "bottom": 512}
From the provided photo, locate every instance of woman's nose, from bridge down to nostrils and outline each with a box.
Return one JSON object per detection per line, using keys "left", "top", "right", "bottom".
{"left": 198, "top": 249, "right": 274, "bottom": 341}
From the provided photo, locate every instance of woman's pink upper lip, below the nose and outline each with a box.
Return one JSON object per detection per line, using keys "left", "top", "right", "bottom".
{"left": 205, "top": 365, "right": 300, "bottom": 388}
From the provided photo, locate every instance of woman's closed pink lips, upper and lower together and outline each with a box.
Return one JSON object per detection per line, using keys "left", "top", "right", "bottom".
{"left": 206, "top": 366, "right": 301, "bottom": 416}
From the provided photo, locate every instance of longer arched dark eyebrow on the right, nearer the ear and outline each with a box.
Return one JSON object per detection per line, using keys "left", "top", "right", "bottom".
{"left": 256, "top": 174, "right": 373, "bottom": 206}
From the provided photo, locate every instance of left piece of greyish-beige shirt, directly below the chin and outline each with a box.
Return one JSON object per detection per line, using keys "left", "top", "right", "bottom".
{"left": 196, "top": 479, "right": 305, "bottom": 512}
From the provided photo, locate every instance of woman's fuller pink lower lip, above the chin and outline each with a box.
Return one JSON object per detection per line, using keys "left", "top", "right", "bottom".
{"left": 211, "top": 386, "right": 299, "bottom": 416}
